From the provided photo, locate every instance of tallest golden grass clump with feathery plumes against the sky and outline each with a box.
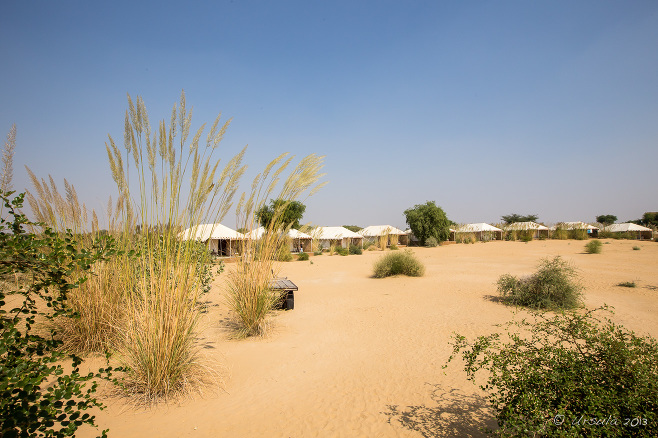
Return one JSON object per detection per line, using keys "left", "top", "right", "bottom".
{"left": 106, "top": 92, "right": 246, "bottom": 401}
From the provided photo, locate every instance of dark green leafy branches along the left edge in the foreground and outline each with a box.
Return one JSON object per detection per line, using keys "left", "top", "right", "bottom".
{"left": 0, "top": 192, "right": 115, "bottom": 437}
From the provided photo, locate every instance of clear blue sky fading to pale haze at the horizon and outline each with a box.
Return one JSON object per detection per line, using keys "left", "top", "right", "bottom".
{"left": 0, "top": 0, "right": 658, "bottom": 231}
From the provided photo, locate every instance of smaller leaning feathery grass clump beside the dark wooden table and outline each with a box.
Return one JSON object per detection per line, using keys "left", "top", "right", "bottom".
{"left": 226, "top": 154, "right": 325, "bottom": 337}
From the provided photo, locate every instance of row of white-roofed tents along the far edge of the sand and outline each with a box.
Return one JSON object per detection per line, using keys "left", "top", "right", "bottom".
{"left": 181, "top": 222, "right": 652, "bottom": 255}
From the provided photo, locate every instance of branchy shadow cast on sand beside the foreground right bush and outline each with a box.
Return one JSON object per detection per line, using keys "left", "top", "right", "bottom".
{"left": 382, "top": 383, "right": 497, "bottom": 438}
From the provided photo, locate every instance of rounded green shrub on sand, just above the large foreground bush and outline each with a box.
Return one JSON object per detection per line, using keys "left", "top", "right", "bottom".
{"left": 497, "top": 256, "right": 582, "bottom": 309}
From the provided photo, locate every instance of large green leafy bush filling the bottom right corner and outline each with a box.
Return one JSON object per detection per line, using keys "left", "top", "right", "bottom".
{"left": 444, "top": 307, "right": 658, "bottom": 437}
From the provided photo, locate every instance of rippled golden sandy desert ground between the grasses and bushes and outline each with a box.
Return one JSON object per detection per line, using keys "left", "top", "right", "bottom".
{"left": 81, "top": 240, "right": 658, "bottom": 437}
